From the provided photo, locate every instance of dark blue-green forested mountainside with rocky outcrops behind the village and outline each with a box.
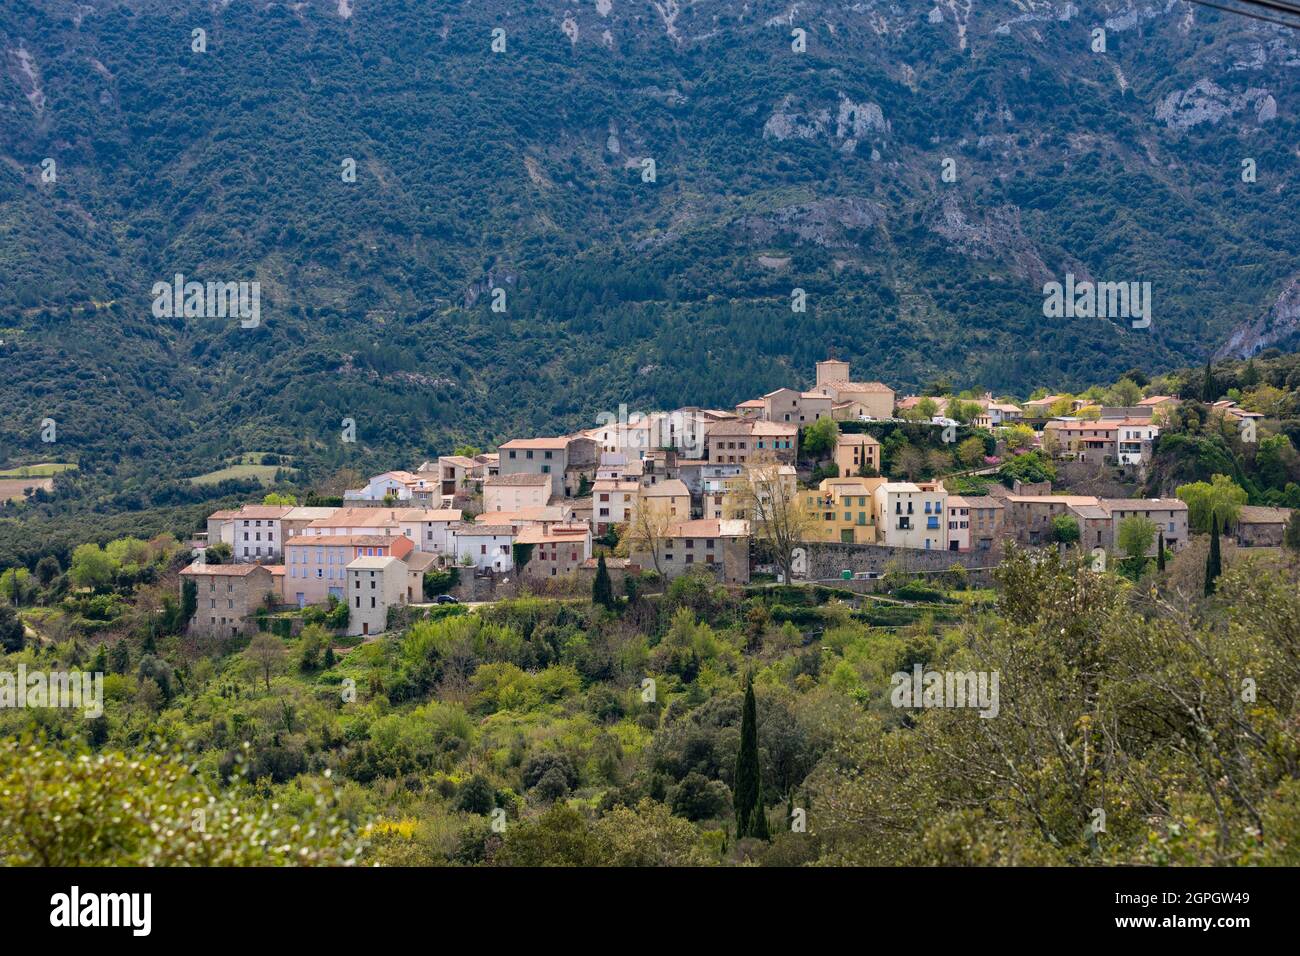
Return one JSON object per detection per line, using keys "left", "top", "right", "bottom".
{"left": 0, "top": 0, "right": 1300, "bottom": 522}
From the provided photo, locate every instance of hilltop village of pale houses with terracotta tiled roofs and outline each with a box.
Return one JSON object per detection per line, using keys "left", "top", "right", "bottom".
{"left": 181, "top": 359, "right": 1290, "bottom": 636}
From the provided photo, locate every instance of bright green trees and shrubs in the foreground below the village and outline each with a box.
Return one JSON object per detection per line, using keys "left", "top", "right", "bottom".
{"left": 0, "top": 541, "right": 1300, "bottom": 866}
